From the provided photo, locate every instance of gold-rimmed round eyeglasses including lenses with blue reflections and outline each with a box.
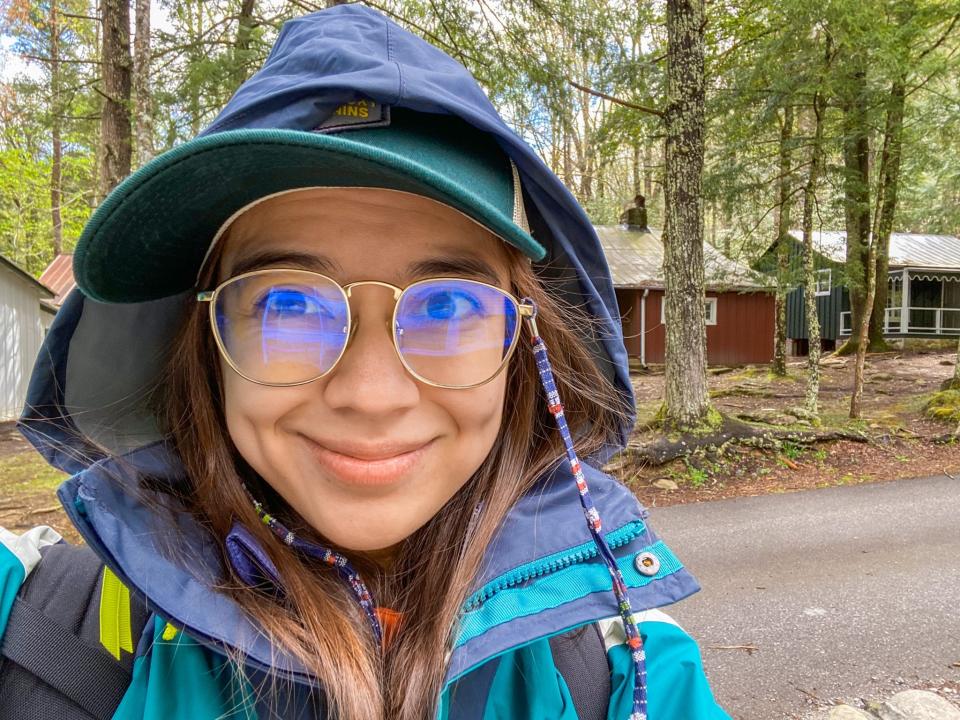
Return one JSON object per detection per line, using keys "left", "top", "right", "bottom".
{"left": 197, "top": 268, "right": 536, "bottom": 389}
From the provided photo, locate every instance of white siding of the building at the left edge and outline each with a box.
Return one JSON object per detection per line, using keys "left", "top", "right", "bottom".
{"left": 0, "top": 264, "right": 44, "bottom": 421}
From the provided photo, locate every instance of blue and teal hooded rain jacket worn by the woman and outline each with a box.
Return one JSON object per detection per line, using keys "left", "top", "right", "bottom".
{"left": 0, "top": 5, "right": 727, "bottom": 720}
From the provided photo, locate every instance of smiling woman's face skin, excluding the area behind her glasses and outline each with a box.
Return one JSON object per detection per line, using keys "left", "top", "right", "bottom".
{"left": 218, "top": 188, "right": 509, "bottom": 551}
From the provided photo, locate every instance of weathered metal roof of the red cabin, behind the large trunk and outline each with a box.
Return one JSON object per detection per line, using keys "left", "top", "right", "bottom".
{"left": 594, "top": 225, "right": 771, "bottom": 290}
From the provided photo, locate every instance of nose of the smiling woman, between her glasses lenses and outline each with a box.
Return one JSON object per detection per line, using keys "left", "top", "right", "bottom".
{"left": 323, "top": 288, "right": 420, "bottom": 419}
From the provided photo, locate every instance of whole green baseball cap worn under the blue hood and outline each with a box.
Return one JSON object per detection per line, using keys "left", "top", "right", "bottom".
{"left": 73, "top": 105, "right": 546, "bottom": 303}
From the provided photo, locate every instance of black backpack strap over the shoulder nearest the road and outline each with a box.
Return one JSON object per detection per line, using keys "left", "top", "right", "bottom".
{"left": 550, "top": 623, "right": 610, "bottom": 720}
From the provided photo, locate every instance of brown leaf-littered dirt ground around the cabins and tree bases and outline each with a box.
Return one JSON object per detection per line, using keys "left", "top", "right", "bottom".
{"left": 0, "top": 350, "right": 960, "bottom": 542}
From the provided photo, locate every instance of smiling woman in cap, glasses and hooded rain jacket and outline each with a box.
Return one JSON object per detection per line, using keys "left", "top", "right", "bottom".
{"left": 0, "top": 6, "right": 726, "bottom": 720}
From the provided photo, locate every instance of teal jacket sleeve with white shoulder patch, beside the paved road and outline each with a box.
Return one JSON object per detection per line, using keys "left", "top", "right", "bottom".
{"left": 600, "top": 610, "right": 730, "bottom": 720}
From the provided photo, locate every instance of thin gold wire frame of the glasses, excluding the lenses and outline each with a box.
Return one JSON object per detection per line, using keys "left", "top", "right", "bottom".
{"left": 196, "top": 268, "right": 537, "bottom": 390}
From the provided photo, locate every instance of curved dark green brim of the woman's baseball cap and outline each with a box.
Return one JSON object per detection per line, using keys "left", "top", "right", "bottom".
{"left": 73, "top": 130, "right": 546, "bottom": 303}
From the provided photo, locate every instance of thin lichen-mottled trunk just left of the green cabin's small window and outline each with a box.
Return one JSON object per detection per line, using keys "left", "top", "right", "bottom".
{"left": 803, "top": 89, "right": 829, "bottom": 415}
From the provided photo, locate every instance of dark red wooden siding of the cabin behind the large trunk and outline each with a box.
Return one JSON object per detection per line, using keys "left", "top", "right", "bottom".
{"left": 617, "top": 290, "right": 774, "bottom": 365}
